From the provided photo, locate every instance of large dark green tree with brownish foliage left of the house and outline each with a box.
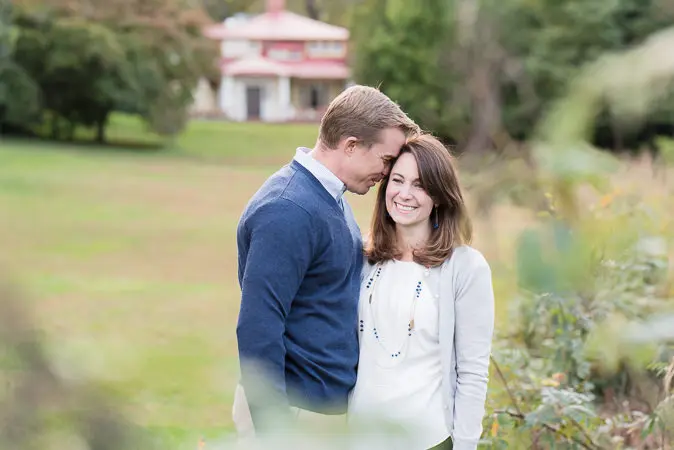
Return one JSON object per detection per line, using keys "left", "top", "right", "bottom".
{"left": 11, "top": 0, "right": 216, "bottom": 141}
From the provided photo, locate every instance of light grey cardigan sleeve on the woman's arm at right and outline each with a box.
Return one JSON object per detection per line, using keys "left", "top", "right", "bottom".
{"left": 452, "top": 249, "right": 494, "bottom": 450}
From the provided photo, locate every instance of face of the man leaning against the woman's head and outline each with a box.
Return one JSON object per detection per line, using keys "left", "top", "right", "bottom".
{"left": 344, "top": 128, "right": 406, "bottom": 195}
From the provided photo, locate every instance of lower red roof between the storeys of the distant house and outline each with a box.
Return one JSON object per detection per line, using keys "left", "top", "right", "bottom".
{"left": 221, "top": 57, "right": 350, "bottom": 80}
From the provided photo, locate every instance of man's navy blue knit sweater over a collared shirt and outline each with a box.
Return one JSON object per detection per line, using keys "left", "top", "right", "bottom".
{"left": 236, "top": 161, "right": 363, "bottom": 427}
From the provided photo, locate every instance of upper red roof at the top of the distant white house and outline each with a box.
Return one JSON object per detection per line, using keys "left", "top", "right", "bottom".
{"left": 205, "top": 10, "right": 349, "bottom": 41}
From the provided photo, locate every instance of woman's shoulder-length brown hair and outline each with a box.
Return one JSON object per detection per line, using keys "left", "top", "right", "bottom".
{"left": 365, "top": 134, "right": 472, "bottom": 267}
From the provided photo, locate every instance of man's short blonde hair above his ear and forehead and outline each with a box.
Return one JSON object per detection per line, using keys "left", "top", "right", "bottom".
{"left": 318, "top": 85, "right": 420, "bottom": 148}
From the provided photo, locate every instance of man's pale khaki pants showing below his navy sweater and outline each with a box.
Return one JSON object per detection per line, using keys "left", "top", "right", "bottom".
{"left": 232, "top": 384, "right": 346, "bottom": 440}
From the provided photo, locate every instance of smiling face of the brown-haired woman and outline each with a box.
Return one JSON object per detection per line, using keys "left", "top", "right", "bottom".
{"left": 386, "top": 153, "right": 433, "bottom": 227}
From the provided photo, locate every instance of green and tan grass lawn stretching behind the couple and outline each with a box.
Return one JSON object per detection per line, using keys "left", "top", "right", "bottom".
{"left": 0, "top": 118, "right": 668, "bottom": 448}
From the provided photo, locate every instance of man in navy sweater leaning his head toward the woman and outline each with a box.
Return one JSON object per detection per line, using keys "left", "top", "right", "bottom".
{"left": 233, "top": 86, "right": 419, "bottom": 435}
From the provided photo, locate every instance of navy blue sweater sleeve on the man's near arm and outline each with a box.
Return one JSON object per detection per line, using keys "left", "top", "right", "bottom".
{"left": 236, "top": 200, "right": 313, "bottom": 428}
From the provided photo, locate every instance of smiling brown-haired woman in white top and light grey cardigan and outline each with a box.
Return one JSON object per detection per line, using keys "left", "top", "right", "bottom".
{"left": 349, "top": 135, "right": 494, "bottom": 450}
